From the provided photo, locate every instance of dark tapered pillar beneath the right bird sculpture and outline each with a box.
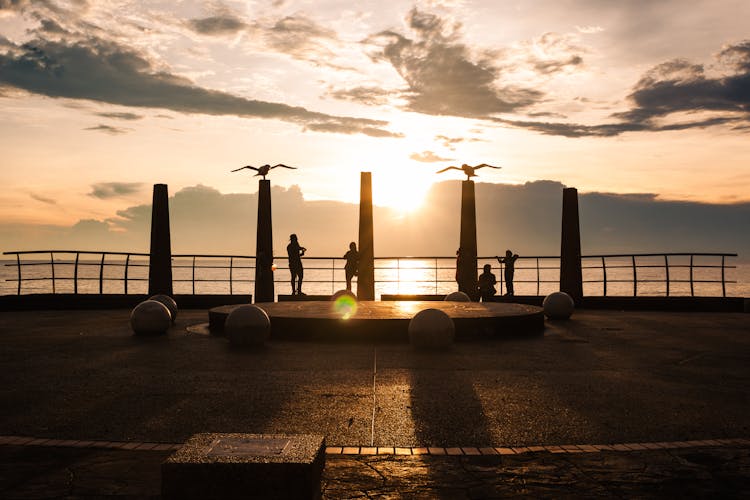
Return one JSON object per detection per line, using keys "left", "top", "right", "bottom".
{"left": 456, "top": 181, "right": 479, "bottom": 300}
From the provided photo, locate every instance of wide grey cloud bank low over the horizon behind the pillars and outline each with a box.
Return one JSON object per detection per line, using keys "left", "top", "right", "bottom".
{"left": 0, "top": 181, "right": 750, "bottom": 259}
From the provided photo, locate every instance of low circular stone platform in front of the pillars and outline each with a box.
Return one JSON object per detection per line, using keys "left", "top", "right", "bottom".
{"left": 208, "top": 301, "right": 544, "bottom": 341}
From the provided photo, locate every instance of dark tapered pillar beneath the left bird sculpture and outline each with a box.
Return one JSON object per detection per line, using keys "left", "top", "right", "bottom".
{"left": 255, "top": 179, "right": 274, "bottom": 302}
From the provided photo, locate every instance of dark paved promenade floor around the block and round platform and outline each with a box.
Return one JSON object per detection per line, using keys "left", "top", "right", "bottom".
{"left": 0, "top": 310, "right": 750, "bottom": 498}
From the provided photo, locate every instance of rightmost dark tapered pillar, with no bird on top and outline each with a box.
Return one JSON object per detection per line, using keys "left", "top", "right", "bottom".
{"left": 560, "top": 188, "right": 583, "bottom": 302}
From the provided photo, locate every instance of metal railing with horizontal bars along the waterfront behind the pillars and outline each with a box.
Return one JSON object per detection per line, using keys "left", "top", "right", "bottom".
{"left": 4, "top": 250, "right": 737, "bottom": 297}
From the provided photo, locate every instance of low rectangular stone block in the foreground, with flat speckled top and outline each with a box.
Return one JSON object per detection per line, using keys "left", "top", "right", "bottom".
{"left": 161, "top": 433, "right": 325, "bottom": 500}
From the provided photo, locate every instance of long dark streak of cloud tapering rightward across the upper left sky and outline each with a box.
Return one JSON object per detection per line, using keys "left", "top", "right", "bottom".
{"left": 0, "top": 37, "right": 394, "bottom": 137}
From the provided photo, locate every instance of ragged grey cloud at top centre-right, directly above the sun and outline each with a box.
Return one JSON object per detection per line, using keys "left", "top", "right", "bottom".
{"left": 366, "top": 8, "right": 543, "bottom": 118}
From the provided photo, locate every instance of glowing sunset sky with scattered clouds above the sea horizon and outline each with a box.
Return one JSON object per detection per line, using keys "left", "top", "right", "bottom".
{"left": 0, "top": 0, "right": 750, "bottom": 255}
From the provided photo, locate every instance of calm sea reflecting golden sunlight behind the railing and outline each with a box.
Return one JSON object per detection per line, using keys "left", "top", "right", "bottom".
{"left": 0, "top": 255, "right": 750, "bottom": 297}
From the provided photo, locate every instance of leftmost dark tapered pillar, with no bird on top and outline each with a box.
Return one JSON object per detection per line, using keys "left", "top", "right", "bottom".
{"left": 148, "top": 184, "right": 172, "bottom": 296}
